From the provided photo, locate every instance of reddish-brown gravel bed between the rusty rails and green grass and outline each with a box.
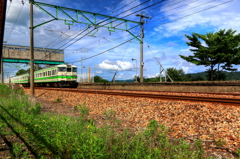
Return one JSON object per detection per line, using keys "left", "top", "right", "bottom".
{"left": 0, "top": 89, "right": 240, "bottom": 158}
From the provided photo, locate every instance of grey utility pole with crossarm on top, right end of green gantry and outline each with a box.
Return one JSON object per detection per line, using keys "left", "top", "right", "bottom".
{"left": 136, "top": 14, "right": 149, "bottom": 83}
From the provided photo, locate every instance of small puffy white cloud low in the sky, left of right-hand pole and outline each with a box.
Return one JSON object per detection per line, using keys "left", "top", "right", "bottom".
{"left": 97, "top": 60, "right": 134, "bottom": 71}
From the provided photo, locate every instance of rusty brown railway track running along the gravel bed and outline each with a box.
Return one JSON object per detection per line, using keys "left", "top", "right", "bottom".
{"left": 24, "top": 87, "right": 240, "bottom": 105}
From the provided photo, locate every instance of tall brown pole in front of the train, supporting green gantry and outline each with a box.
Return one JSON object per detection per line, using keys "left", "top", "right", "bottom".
{"left": 29, "top": 0, "right": 34, "bottom": 97}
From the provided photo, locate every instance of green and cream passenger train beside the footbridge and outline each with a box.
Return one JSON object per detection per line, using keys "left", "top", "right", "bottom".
{"left": 9, "top": 64, "right": 77, "bottom": 87}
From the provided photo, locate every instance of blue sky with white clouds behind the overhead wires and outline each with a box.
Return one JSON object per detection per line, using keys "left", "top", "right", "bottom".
{"left": 4, "top": 0, "right": 240, "bottom": 80}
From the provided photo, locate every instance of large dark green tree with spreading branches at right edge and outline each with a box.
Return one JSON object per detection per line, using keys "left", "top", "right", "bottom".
{"left": 179, "top": 29, "right": 240, "bottom": 81}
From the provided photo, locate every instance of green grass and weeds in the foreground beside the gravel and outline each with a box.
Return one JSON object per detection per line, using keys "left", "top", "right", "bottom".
{"left": 0, "top": 85, "right": 225, "bottom": 159}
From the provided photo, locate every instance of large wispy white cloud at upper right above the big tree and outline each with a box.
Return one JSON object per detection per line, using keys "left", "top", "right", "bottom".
{"left": 153, "top": 0, "right": 240, "bottom": 37}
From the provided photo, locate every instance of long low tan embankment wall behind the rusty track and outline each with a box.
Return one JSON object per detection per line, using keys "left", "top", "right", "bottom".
{"left": 78, "top": 81, "right": 240, "bottom": 92}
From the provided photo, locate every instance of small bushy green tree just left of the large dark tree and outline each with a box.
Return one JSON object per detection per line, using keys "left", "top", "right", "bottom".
{"left": 167, "top": 67, "right": 185, "bottom": 81}
